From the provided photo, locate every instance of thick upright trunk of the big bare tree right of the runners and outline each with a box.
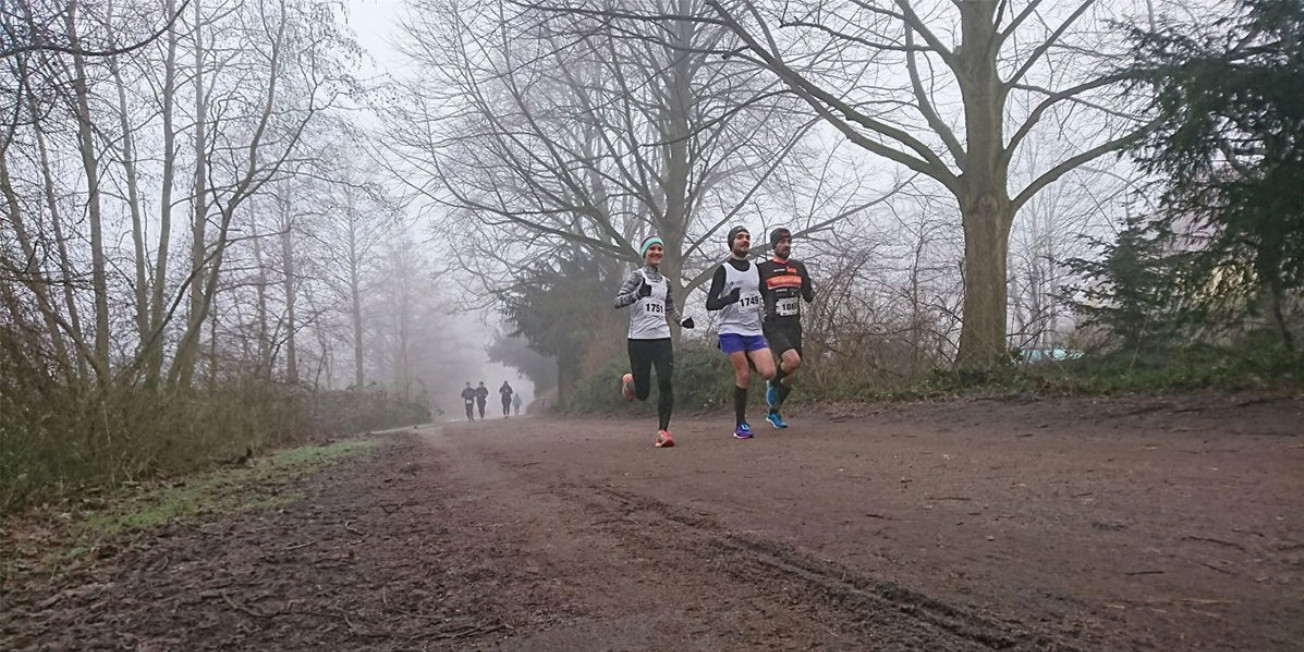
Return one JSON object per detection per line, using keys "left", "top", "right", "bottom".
{"left": 956, "top": 1, "right": 1015, "bottom": 368}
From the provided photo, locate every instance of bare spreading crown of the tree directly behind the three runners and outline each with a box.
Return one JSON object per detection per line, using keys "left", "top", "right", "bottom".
{"left": 393, "top": 0, "right": 855, "bottom": 305}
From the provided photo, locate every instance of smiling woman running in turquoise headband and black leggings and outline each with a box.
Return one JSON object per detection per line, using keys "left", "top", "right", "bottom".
{"left": 615, "top": 236, "right": 692, "bottom": 449}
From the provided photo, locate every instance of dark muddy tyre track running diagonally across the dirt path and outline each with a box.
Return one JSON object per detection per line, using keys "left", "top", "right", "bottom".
{"left": 553, "top": 484, "right": 1081, "bottom": 652}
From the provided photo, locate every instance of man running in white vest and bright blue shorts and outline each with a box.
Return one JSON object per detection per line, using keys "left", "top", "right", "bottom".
{"left": 707, "top": 227, "right": 775, "bottom": 439}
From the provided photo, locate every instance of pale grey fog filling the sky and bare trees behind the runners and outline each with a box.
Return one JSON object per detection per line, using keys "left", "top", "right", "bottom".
{"left": 0, "top": 0, "right": 1241, "bottom": 413}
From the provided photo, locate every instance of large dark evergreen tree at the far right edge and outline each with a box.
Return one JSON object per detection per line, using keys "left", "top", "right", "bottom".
{"left": 1131, "top": 0, "right": 1304, "bottom": 351}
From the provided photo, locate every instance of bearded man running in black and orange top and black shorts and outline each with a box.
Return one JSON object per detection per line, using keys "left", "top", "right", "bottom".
{"left": 758, "top": 228, "right": 815, "bottom": 428}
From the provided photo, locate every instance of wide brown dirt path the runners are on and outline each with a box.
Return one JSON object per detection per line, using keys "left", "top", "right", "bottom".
{"left": 0, "top": 396, "right": 1304, "bottom": 651}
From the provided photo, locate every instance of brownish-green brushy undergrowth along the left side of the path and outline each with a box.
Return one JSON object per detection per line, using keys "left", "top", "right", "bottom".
{"left": 0, "top": 379, "right": 430, "bottom": 514}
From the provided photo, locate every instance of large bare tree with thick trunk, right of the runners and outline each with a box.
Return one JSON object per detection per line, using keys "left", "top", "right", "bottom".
{"left": 549, "top": 0, "right": 1168, "bottom": 366}
